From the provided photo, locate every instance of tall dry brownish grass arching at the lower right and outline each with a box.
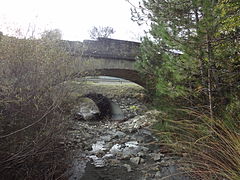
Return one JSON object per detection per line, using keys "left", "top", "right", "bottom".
{"left": 159, "top": 110, "right": 240, "bottom": 180}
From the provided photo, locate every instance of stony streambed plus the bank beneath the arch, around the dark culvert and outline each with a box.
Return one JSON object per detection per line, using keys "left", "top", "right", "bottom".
{"left": 60, "top": 81, "right": 193, "bottom": 180}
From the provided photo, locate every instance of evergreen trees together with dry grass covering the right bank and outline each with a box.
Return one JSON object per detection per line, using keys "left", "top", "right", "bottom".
{"left": 132, "top": 0, "right": 240, "bottom": 180}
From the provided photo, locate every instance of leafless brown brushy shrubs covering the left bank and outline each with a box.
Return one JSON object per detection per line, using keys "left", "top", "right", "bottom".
{"left": 0, "top": 31, "right": 79, "bottom": 179}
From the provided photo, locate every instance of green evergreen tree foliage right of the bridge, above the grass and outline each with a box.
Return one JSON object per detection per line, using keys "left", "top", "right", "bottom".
{"left": 132, "top": 0, "right": 240, "bottom": 115}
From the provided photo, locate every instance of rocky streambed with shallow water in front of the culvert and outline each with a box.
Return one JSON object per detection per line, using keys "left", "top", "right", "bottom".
{"left": 62, "top": 110, "right": 189, "bottom": 180}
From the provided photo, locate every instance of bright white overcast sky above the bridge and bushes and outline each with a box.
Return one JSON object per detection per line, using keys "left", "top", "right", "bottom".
{"left": 0, "top": 0, "right": 147, "bottom": 41}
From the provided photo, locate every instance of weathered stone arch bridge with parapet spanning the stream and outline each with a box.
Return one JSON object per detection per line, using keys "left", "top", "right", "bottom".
{"left": 63, "top": 38, "right": 145, "bottom": 87}
